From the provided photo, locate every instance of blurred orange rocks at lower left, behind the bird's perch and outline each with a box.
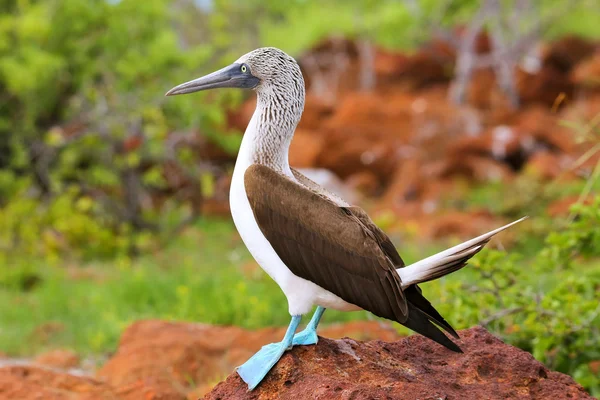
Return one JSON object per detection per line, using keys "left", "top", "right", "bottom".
{"left": 0, "top": 320, "right": 400, "bottom": 400}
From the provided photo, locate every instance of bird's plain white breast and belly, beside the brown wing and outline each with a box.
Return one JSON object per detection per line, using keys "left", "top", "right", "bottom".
{"left": 229, "top": 152, "right": 359, "bottom": 315}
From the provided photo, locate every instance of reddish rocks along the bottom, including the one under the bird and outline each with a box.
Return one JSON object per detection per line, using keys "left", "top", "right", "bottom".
{"left": 0, "top": 321, "right": 592, "bottom": 400}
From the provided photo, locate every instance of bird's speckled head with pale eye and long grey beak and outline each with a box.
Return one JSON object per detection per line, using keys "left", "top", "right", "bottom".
{"left": 166, "top": 47, "right": 304, "bottom": 96}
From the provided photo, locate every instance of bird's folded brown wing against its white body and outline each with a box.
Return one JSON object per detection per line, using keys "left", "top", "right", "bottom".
{"left": 244, "top": 164, "right": 408, "bottom": 323}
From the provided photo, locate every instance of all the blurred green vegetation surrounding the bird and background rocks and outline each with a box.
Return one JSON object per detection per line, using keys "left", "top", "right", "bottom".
{"left": 0, "top": 0, "right": 600, "bottom": 395}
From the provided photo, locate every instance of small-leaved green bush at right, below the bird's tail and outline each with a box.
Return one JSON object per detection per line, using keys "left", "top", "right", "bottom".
{"left": 410, "top": 196, "right": 600, "bottom": 395}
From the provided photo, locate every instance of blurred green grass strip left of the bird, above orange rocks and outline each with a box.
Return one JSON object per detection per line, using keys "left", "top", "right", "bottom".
{"left": 0, "top": 220, "right": 428, "bottom": 356}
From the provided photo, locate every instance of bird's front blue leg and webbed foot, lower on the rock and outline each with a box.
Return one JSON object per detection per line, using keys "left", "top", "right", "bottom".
{"left": 237, "top": 315, "right": 302, "bottom": 390}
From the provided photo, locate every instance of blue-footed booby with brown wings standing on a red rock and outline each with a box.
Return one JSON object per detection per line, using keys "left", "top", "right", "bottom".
{"left": 166, "top": 47, "right": 527, "bottom": 390}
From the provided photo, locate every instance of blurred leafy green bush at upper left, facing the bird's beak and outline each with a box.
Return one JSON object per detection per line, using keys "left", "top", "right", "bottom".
{"left": 0, "top": 0, "right": 244, "bottom": 265}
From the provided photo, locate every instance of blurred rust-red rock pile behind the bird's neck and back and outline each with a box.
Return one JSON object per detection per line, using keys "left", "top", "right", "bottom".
{"left": 192, "top": 35, "right": 600, "bottom": 238}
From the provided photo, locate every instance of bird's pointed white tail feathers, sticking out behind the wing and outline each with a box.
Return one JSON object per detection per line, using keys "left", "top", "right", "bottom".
{"left": 396, "top": 217, "right": 528, "bottom": 288}
